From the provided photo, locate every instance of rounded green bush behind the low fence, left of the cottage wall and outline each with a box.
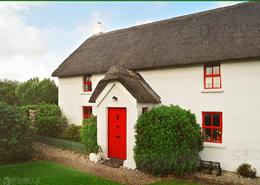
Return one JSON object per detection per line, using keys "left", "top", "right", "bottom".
{"left": 35, "top": 103, "right": 67, "bottom": 137}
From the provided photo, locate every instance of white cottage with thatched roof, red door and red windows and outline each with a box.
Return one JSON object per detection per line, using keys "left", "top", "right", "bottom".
{"left": 53, "top": 3, "right": 260, "bottom": 176}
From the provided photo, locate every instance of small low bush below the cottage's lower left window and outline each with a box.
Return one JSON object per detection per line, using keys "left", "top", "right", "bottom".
{"left": 62, "top": 124, "right": 81, "bottom": 142}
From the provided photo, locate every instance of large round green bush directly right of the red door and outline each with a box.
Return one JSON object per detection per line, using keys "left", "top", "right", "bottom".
{"left": 134, "top": 105, "right": 203, "bottom": 175}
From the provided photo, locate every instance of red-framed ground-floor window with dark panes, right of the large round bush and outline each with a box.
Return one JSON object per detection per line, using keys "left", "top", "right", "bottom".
{"left": 202, "top": 112, "right": 222, "bottom": 143}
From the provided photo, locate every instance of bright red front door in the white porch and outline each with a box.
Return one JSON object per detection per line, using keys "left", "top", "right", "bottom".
{"left": 108, "top": 108, "right": 126, "bottom": 160}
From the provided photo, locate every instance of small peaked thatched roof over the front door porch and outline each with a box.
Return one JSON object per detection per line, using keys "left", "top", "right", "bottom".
{"left": 89, "top": 66, "right": 161, "bottom": 103}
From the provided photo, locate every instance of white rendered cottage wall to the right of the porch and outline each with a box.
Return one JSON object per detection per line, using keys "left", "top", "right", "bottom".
{"left": 140, "top": 61, "right": 260, "bottom": 176}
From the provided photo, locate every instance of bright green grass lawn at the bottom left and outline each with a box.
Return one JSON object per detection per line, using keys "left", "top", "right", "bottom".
{"left": 0, "top": 162, "right": 118, "bottom": 185}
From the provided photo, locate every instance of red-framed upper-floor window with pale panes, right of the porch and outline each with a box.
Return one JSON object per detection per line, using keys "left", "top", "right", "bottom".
{"left": 204, "top": 64, "right": 221, "bottom": 89}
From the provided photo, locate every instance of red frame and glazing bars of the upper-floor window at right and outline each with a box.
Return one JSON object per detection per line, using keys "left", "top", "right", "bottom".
{"left": 204, "top": 64, "right": 222, "bottom": 89}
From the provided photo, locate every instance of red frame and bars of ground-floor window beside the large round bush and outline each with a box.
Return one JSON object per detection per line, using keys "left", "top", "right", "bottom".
{"left": 202, "top": 112, "right": 223, "bottom": 143}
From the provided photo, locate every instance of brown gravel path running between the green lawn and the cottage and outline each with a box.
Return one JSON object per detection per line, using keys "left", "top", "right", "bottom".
{"left": 33, "top": 143, "right": 260, "bottom": 185}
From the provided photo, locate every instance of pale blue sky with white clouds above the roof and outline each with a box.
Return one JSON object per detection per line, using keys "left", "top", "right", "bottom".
{"left": 0, "top": 1, "right": 242, "bottom": 81}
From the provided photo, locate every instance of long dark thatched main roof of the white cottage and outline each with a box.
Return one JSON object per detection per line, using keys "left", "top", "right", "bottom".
{"left": 53, "top": 3, "right": 260, "bottom": 77}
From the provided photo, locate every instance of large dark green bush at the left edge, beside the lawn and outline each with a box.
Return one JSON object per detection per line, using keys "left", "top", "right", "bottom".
{"left": 0, "top": 103, "right": 33, "bottom": 163}
